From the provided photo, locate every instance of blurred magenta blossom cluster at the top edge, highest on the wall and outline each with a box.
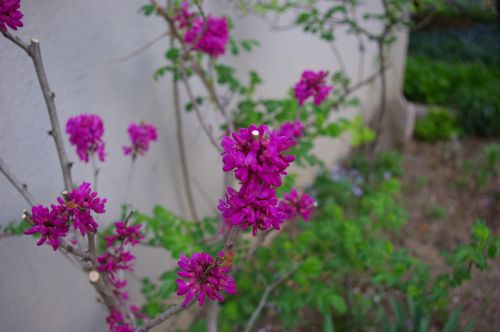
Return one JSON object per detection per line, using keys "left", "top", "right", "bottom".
{"left": 174, "top": 2, "right": 229, "bottom": 58}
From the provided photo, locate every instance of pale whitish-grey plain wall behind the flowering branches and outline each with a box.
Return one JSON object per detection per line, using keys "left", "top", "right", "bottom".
{"left": 0, "top": 0, "right": 404, "bottom": 332}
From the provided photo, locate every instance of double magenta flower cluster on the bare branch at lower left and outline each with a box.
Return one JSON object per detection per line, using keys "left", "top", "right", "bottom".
{"left": 24, "top": 182, "right": 106, "bottom": 250}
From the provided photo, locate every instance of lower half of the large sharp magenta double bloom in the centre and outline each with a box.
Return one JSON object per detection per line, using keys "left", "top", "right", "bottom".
{"left": 217, "top": 185, "right": 286, "bottom": 235}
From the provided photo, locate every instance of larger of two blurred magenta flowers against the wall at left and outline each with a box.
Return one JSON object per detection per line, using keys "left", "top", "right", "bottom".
{"left": 66, "top": 114, "right": 105, "bottom": 163}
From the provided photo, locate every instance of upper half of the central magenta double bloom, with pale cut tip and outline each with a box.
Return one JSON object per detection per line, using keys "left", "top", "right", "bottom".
{"left": 221, "top": 125, "right": 295, "bottom": 191}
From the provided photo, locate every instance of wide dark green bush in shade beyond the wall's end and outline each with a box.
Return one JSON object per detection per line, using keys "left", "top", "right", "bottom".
{"left": 404, "top": 56, "right": 500, "bottom": 137}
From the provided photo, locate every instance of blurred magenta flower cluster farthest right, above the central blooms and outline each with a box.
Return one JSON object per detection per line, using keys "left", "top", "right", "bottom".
{"left": 294, "top": 70, "right": 333, "bottom": 105}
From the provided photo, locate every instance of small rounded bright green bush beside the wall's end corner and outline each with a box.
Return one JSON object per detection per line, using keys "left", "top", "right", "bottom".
{"left": 415, "top": 107, "right": 461, "bottom": 142}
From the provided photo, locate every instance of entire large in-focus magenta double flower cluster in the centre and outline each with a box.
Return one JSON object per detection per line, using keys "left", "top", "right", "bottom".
{"left": 218, "top": 125, "right": 295, "bottom": 235}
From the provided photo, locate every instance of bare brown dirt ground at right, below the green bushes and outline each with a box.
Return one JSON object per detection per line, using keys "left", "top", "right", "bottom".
{"left": 402, "top": 139, "right": 500, "bottom": 332}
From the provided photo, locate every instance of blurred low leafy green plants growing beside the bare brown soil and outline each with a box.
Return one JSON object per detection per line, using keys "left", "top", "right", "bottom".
{"left": 211, "top": 154, "right": 500, "bottom": 331}
